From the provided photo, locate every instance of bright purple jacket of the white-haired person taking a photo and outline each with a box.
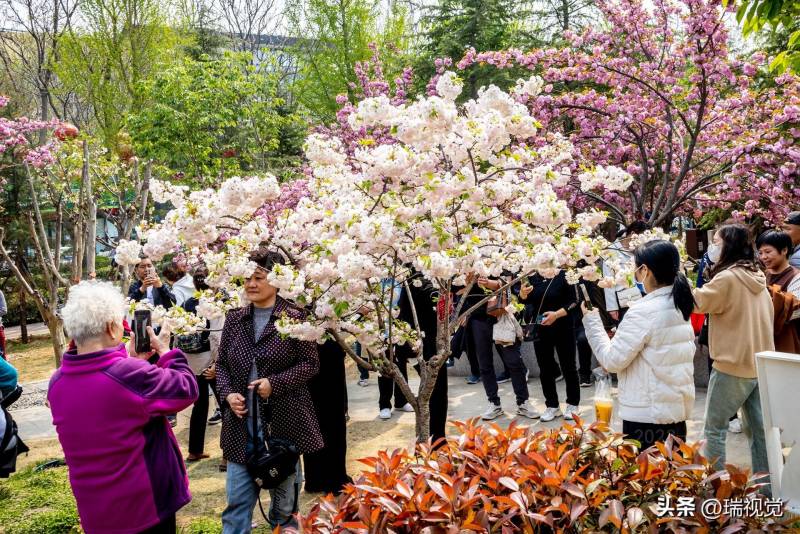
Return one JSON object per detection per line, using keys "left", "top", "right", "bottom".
{"left": 47, "top": 345, "right": 198, "bottom": 534}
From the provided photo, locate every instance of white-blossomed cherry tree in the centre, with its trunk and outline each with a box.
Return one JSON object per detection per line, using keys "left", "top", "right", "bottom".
{"left": 116, "top": 72, "right": 630, "bottom": 440}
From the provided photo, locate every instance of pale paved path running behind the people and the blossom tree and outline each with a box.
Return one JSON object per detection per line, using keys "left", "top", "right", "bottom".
{"left": 12, "top": 371, "right": 750, "bottom": 468}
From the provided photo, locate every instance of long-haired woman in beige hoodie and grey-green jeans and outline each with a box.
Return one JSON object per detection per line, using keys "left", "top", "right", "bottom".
{"left": 694, "top": 224, "right": 775, "bottom": 488}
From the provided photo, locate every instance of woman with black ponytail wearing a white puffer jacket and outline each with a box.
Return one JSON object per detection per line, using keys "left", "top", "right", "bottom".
{"left": 583, "top": 240, "right": 695, "bottom": 449}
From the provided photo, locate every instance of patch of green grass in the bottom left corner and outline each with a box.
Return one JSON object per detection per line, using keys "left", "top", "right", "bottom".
{"left": 0, "top": 467, "right": 80, "bottom": 534}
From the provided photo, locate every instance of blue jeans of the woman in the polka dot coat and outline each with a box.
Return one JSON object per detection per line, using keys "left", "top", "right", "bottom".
{"left": 222, "top": 461, "right": 303, "bottom": 534}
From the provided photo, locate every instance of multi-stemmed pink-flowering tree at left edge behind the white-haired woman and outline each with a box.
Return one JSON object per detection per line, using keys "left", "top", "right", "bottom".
{"left": 0, "top": 96, "right": 148, "bottom": 366}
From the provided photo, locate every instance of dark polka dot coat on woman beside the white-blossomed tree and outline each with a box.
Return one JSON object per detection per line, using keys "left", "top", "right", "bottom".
{"left": 217, "top": 297, "right": 324, "bottom": 464}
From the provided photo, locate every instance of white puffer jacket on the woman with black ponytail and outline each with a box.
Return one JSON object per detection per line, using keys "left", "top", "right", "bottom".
{"left": 583, "top": 286, "right": 695, "bottom": 424}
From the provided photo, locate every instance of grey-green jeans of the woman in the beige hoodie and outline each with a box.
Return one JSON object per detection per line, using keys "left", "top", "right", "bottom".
{"left": 705, "top": 369, "right": 769, "bottom": 494}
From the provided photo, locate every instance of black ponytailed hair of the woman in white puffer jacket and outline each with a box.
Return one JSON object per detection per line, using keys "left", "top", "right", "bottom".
{"left": 633, "top": 239, "right": 694, "bottom": 321}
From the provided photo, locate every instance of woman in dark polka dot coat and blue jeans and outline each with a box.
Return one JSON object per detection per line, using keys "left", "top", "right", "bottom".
{"left": 216, "top": 249, "right": 324, "bottom": 534}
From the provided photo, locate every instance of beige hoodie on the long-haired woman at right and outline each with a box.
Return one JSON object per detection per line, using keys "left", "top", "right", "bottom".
{"left": 694, "top": 266, "right": 775, "bottom": 378}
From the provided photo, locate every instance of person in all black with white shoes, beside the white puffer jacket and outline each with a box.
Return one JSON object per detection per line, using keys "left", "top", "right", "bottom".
{"left": 519, "top": 271, "right": 581, "bottom": 422}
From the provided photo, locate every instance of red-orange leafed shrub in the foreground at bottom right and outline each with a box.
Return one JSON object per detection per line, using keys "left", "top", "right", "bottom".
{"left": 301, "top": 419, "right": 789, "bottom": 534}
